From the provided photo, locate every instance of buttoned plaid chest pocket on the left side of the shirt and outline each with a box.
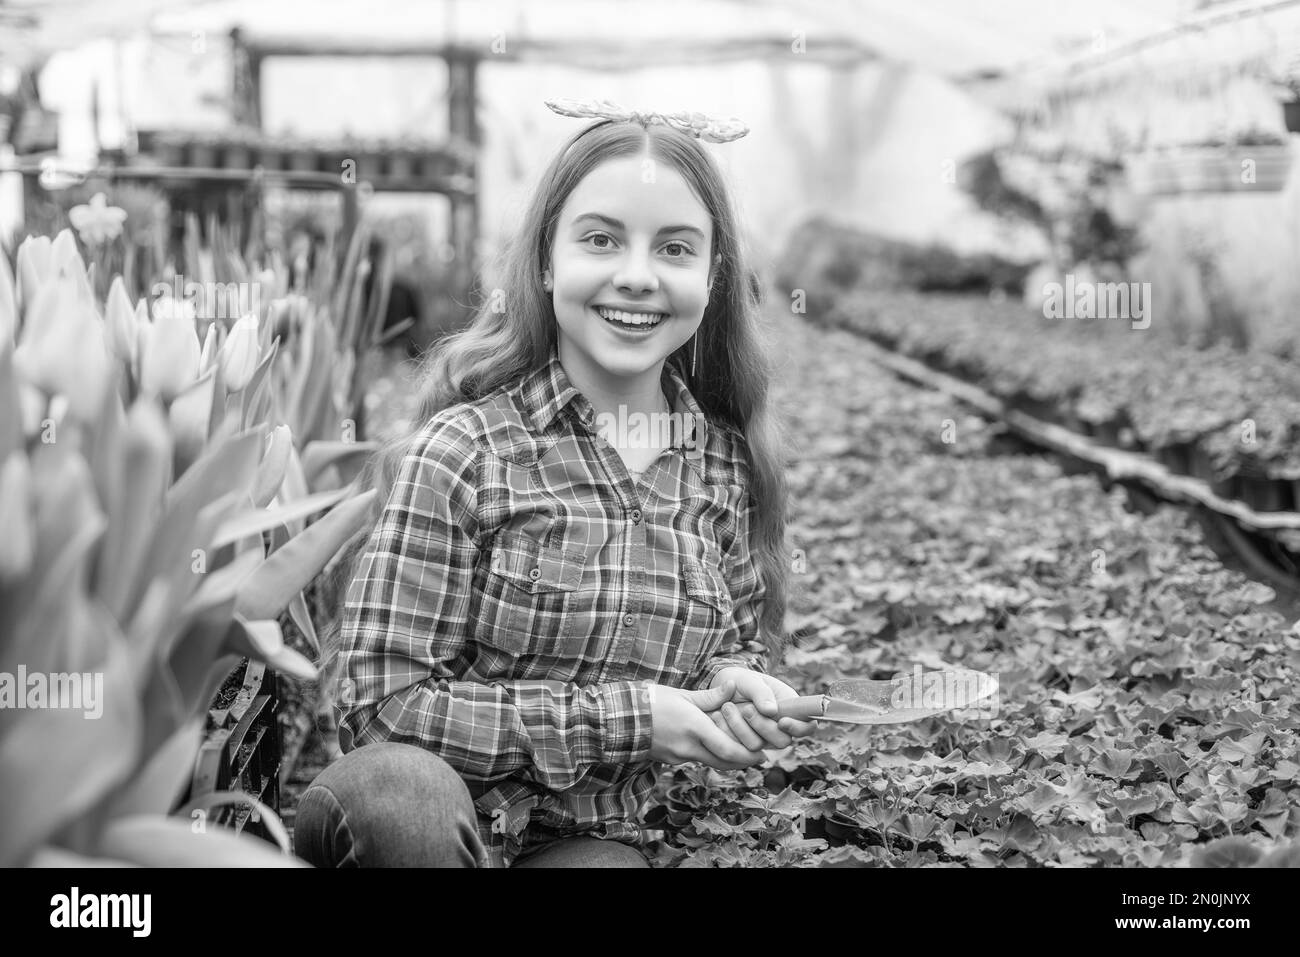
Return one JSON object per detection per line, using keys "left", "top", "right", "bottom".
{"left": 481, "top": 533, "right": 586, "bottom": 654}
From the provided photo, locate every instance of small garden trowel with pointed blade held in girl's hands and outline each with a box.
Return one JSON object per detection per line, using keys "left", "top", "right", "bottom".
{"left": 776, "top": 670, "right": 997, "bottom": 724}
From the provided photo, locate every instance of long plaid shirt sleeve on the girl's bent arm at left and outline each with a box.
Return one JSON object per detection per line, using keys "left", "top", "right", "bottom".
{"left": 338, "top": 417, "right": 653, "bottom": 791}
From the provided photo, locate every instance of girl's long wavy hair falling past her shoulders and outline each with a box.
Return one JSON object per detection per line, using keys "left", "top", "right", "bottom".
{"left": 322, "top": 120, "right": 788, "bottom": 668}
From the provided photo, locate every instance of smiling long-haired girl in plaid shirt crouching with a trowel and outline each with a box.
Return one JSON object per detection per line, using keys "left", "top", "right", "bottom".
{"left": 296, "top": 101, "right": 813, "bottom": 867}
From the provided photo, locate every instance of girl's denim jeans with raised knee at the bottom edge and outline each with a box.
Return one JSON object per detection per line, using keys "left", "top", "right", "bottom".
{"left": 294, "top": 742, "right": 650, "bottom": 867}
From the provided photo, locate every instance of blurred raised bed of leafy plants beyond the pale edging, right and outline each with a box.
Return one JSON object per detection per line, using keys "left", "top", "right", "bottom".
{"left": 815, "top": 287, "right": 1300, "bottom": 501}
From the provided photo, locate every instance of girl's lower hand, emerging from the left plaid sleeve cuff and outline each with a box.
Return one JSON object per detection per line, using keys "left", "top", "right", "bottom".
{"left": 650, "top": 681, "right": 767, "bottom": 771}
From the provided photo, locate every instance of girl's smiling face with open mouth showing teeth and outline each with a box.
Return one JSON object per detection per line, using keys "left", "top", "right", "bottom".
{"left": 546, "top": 156, "right": 712, "bottom": 394}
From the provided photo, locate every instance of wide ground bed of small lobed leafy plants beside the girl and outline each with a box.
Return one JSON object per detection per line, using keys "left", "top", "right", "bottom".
{"left": 645, "top": 308, "right": 1300, "bottom": 867}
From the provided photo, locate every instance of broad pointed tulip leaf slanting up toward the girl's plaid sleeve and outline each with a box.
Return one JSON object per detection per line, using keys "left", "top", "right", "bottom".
{"left": 235, "top": 489, "right": 378, "bottom": 618}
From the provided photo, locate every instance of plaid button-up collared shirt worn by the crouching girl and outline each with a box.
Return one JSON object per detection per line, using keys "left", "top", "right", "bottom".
{"left": 339, "top": 350, "right": 768, "bottom": 866}
